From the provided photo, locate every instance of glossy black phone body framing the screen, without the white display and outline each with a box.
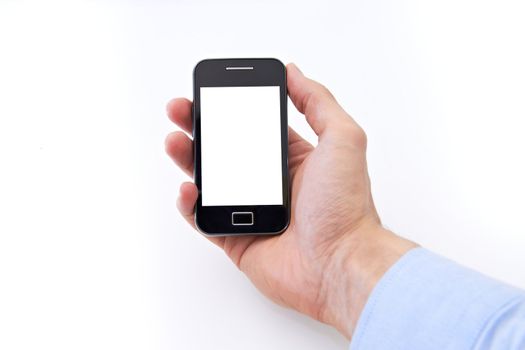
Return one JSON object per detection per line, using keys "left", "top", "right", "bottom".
{"left": 193, "top": 58, "right": 290, "bottom": 236}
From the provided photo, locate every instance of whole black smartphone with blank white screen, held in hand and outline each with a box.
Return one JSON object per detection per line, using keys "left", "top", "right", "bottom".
{"left": 193, "top": 58, "right": 290, "bottom": 236}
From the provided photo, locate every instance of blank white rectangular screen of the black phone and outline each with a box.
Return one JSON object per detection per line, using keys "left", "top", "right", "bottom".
{"left": 200, "top": 86, "right": 283, "bottom": 206}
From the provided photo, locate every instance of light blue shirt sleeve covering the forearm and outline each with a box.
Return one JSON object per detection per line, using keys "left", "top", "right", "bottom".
{"left": 350, "top": 248, "right": 525, "bottom": 350}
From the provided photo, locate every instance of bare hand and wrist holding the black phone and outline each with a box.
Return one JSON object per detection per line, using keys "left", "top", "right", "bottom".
{"left": 166, "top": 64, "right": 415, "bottom": 339}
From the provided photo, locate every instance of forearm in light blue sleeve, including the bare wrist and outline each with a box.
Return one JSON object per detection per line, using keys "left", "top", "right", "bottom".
{"left": 323, "top": 228, "right": 525, "bottom": 350}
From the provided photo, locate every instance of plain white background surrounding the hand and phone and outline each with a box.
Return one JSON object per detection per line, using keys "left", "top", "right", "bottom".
{"left": 0, "top": 0, "right": 525, "bottom": 349}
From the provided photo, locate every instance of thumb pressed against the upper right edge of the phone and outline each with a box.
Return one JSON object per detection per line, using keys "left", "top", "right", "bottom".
{"left": 286, "top": 63, "right": 352, "bottom": 136}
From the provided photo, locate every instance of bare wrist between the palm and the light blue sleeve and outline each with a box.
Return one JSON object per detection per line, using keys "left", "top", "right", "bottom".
{"left": 320, "top": 222, "right": 417, "bottom": 339}
